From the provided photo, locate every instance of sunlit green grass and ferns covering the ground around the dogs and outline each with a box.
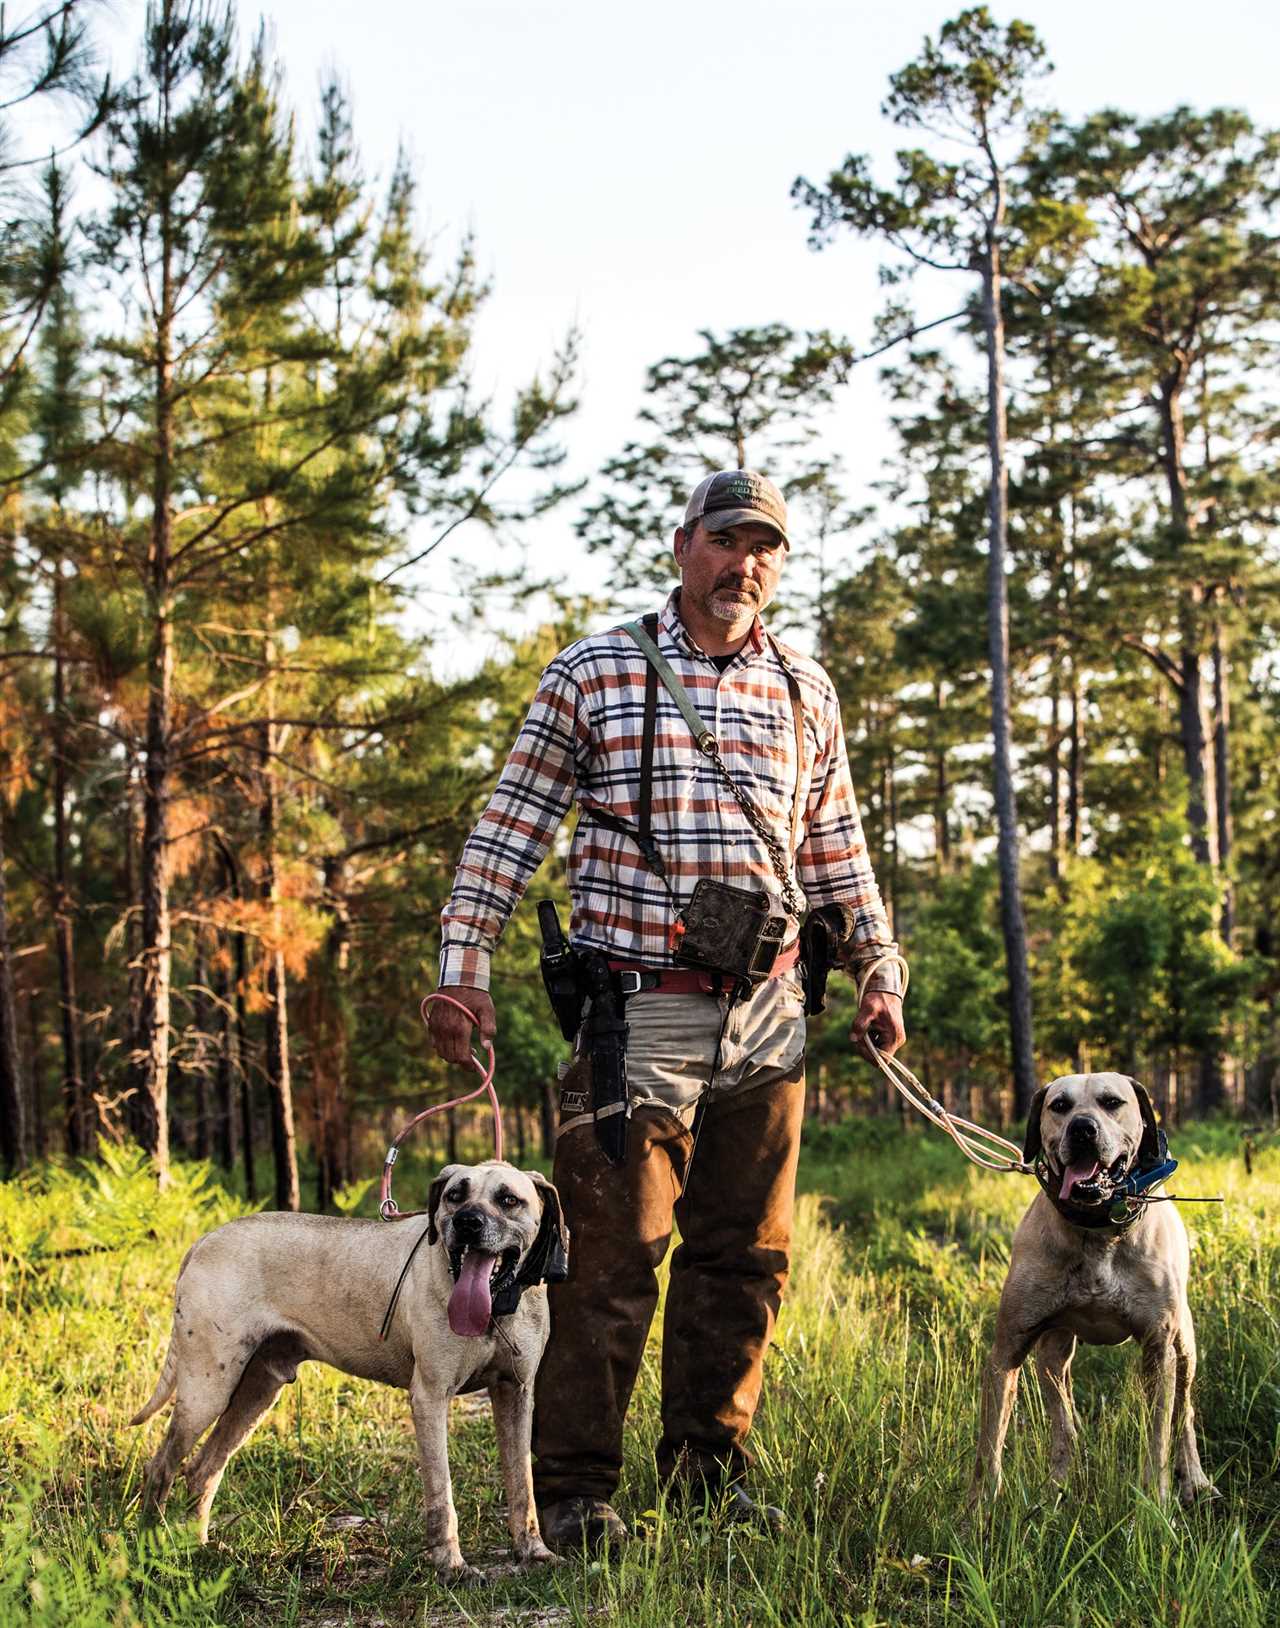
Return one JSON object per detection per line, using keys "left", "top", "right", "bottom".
{"left": 0, "top": 1120, "right": 1280, "bottom": 1628}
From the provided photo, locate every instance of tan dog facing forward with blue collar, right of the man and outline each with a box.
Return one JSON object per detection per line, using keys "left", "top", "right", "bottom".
{"left": 969, "top": 1074, "right": 1213, "bottom": 1504}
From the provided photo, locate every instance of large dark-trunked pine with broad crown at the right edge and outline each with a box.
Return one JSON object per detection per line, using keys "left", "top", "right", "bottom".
{"left": 1036, "top": 107, "right": 1280, "bottom": 905}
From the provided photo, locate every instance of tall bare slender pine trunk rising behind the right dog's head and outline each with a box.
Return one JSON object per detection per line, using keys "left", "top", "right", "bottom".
{"left": 982, "top": 236, "right": 1036, "bottom": 1117}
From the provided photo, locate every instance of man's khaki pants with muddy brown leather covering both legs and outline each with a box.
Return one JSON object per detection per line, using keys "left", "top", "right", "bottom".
{"left": 534, "top": 978, "right": 804, "bottom": 1504}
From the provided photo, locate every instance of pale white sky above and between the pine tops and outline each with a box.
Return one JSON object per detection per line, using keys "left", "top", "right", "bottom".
{"left": 97, "top": 0, "right": 1280, "bottom": 660}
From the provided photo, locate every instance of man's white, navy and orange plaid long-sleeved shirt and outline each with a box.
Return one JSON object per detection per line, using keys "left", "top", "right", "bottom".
{"left": 440, "top": 593, "right": 899, "bottom": 990}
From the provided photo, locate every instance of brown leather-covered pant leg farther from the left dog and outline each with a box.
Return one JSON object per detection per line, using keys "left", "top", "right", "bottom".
{"left": 658, "top": 1063, "right": 804, "bottom": 1488}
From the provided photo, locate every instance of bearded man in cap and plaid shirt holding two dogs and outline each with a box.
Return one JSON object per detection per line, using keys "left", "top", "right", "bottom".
{"left": 430, "top": 470, "right": 904, "bottom": 1547}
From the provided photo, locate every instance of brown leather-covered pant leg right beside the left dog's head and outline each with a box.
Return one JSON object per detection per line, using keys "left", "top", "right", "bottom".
{"left": 533, "top": 1065, "right": 690, "bottom": 1506}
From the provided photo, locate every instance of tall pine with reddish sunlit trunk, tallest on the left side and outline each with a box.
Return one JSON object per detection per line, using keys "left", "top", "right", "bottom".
{"left": 87, "top": 0, "right": 327, "bottom": 1177}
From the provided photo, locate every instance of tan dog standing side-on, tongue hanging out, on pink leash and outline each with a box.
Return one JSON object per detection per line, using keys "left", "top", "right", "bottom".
{"left": 129, "top": 1161, "right": 568, "bottom": 1581}
